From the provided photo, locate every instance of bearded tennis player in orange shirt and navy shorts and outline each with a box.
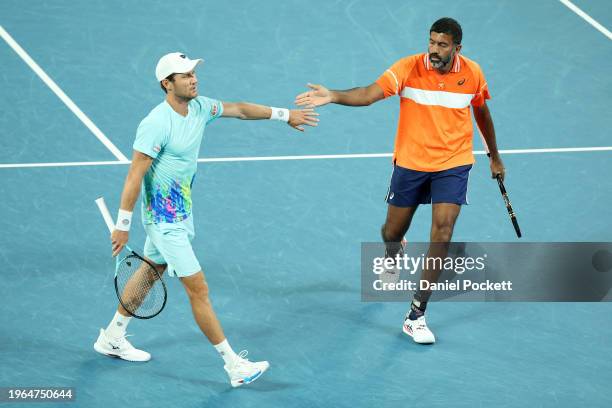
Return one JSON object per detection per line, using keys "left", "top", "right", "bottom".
{"left": 295, "top": 17, "right": 504, "bottom": 344}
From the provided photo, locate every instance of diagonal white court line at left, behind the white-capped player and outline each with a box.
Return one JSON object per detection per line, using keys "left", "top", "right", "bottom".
{"left": 0, "top": 26, "right": 129, "bottom": 163}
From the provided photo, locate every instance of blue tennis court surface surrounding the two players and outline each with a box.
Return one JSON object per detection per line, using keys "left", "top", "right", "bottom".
{"left": 0, "top": 0, "right": 612, "bottom": 407}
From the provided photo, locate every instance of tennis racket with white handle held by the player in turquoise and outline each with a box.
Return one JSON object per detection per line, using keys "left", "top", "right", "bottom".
{"left": 96, "top": 197, "right": 168, "bottom": 319}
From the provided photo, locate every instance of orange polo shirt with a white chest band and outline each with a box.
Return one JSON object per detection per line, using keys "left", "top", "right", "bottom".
{"left": 376, "top": 54, "right": 490, "bottom": 172}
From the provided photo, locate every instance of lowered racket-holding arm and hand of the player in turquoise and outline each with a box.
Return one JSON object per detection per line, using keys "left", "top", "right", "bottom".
{"left": 111, "top": 150, "right": 153, "bottom": 256}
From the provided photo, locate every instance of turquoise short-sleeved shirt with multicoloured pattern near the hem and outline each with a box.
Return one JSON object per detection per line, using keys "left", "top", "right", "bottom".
{"left": 134, "top": 96, "right": 223, "bottom": 224}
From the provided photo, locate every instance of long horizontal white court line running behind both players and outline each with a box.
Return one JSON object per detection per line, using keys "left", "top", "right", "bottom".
{"left": 0, "top": 146, "right": 612, "bottom": 169}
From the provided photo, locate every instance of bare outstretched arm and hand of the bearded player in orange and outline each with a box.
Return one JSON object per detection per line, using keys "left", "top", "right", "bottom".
{"left": 295, "top": 83, "right": 385, "bottom": 106}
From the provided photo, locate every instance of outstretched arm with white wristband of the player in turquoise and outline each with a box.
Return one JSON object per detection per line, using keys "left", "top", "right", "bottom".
{"left": 221, "top": 102, "right": 319, "bottom": 132}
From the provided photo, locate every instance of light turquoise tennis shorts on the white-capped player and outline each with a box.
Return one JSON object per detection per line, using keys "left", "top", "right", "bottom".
{"left": 144, "top": 217, "right": 202, "bottom": 278}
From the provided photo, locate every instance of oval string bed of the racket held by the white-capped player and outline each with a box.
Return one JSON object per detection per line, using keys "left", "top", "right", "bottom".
{"left": 116, "top": 254, "right": 166, "bottom": 318}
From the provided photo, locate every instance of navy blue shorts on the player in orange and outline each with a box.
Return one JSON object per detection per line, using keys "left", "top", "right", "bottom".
{"left": 386, "top": 164, "right": 472, "bottom": 207}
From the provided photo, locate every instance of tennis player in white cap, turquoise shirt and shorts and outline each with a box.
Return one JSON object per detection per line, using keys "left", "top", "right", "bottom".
{"left": 94, "top": 52, "right": 318, "bottom": 387}
